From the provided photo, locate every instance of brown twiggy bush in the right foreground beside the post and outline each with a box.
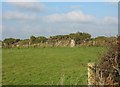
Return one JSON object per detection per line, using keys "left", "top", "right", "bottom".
{"left": 99, "top": 37, "right": 120, "bottom": 86}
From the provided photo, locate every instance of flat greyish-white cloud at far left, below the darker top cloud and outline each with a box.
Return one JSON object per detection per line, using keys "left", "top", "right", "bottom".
{"left": 3, "top": 11, "right": 36, "bottom": 20}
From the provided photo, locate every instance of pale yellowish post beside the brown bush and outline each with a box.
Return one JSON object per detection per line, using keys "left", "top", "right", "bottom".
{"left": 88, "top": 63, "right": 96, "bottom": 86}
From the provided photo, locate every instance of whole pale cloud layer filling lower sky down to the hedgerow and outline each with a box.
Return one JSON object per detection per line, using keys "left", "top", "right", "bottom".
{"left": 3, "top": 7, "right": 118, "bottom": 38}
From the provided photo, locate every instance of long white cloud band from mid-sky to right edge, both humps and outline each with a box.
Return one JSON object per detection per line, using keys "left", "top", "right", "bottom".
{"left": 44, "top": 11, "right": 118, "bottom": 25}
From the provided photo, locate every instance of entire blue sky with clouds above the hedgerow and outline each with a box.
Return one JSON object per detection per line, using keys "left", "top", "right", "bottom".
{"left": 2, "top": 0, "right": 118, "bottom": 39}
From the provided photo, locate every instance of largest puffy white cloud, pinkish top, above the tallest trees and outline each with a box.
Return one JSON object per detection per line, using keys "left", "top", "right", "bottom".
{"left": 44, "top": 11, "right": 95, "bottom": 23}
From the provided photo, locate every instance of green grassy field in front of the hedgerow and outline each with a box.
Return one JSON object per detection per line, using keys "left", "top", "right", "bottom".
{"left": 2, "top": 47, "right": 106, "bottom": 85}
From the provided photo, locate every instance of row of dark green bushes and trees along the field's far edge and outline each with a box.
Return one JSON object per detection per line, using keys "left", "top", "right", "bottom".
{"left": 2, "top": 32, "right": 116, "bottom": 47}
